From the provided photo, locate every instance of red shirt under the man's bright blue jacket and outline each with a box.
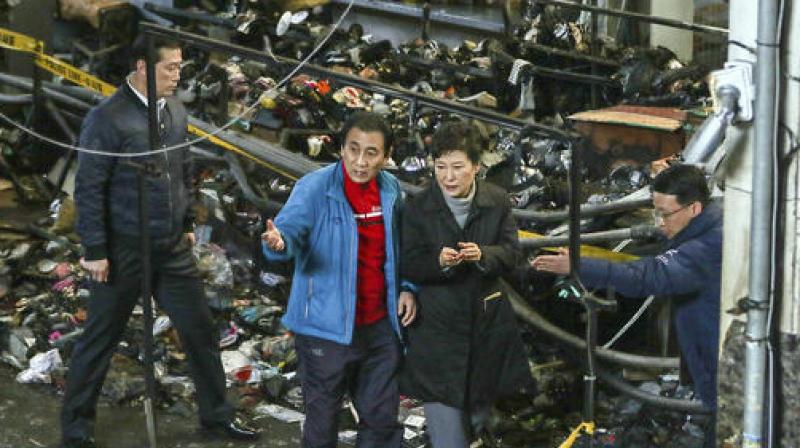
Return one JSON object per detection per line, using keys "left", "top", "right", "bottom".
{"left": 342, "top": 164, "right": 387, "bottom": 325}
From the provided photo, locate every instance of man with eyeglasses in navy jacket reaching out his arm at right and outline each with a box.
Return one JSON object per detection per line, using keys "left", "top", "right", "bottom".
{"left": 531, "top": 165, "right": 722, "bottom": 446}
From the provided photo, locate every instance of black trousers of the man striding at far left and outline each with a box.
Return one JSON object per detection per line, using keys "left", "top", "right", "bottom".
{"left": 61, "top": 236, "right": 233, "bottom": 440}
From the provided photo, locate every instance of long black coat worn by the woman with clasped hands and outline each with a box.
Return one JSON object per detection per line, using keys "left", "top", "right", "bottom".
{"left": 400, "top": 181, "right": 530, "bottom": 410}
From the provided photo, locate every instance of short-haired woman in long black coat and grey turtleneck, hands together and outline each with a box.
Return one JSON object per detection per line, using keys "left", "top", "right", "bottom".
{"left": 400, "top": 122, "right": 530, "bottom": 448}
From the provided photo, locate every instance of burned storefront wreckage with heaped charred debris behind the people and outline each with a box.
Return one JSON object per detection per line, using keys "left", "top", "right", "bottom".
{"left": 0, "top": 0, "right": 788, "bottom": 447}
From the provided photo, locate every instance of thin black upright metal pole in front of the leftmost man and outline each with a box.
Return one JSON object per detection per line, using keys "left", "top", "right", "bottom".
{"left": 138, "top": 34, "right": 159, "bottom": 448}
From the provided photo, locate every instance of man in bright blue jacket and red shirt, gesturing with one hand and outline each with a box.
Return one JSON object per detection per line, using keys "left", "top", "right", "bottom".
{"left": 262, "top": 112, "right": 416, "bottom": 448}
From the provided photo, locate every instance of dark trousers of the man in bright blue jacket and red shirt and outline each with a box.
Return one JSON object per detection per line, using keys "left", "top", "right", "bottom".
{"left": 295, "top": 319, "right": 402, "bottom": 448}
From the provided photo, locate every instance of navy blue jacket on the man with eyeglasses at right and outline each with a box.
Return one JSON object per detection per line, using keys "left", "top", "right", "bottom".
{"left": 580, "top": 203, "right": 722, "bottom": 408}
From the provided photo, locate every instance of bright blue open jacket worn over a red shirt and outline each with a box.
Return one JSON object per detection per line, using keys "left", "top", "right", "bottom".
{"left": 262, "top": 162, "right": 402, "bottom": 344}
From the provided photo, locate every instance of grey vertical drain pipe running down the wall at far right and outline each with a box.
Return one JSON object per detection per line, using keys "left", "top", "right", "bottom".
{"left": 742, "top": 0, "right": 778, "bottom": 448}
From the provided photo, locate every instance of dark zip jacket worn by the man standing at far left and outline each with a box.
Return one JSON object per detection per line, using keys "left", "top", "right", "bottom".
{"left": 75, "top": 83, "right": 191, "bottom": 260}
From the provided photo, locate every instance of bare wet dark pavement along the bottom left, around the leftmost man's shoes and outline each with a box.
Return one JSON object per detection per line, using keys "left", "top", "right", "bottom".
{"left": 0, "top": 366, "right": 300, "bottom": 448}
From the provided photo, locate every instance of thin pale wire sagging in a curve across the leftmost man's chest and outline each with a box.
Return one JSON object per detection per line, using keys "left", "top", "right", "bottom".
{"left": 0, "top": 0, "right": 355, "bottom": 158}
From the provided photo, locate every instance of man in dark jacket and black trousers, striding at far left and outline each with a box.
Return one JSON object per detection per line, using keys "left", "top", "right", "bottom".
{"left": 61, "top": 38, "right": 258, "bottom": 448}
